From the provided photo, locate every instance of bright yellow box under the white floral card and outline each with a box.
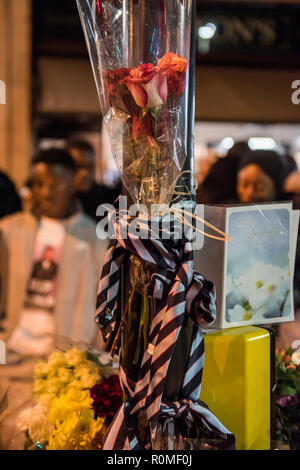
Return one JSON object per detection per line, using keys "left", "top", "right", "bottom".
{"left": 200, "top": 326, "right": 271, "bottom": 450}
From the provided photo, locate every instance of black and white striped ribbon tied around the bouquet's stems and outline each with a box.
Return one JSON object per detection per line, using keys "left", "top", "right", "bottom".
{"left": 96, "top": 210, "right": 232, "bottom": 450}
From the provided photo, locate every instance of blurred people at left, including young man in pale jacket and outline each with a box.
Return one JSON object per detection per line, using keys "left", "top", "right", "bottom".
{"left": 0, "top": 140, "right": 120, "bottom": 358}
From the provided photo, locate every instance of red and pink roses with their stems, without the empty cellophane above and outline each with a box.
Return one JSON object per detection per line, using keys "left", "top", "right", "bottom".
{"left": 104, "top": 52, "right": 187, "bottom": 205}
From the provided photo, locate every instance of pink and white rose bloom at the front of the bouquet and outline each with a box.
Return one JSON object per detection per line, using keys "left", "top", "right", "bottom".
{"left": 124, "top": 64, "right": 168, "bottom": 108}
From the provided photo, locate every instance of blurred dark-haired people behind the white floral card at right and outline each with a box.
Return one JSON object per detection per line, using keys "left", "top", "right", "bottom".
{"left": 197, "top": 142, "right": 300, "bottom": 348}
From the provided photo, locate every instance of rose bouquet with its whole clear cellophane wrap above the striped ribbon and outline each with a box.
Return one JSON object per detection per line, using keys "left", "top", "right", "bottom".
{"left": 77, "top": 0, "right": 191, "bottom": 207}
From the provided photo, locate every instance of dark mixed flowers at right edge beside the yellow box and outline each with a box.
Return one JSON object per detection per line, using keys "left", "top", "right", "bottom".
{"left": 276, "top": 348, "right": 300, "bottom": 450}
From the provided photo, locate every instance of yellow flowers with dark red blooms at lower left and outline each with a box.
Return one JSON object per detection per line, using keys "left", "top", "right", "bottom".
{"left": 17, "top": 347, "right": 123, "bottom": 450}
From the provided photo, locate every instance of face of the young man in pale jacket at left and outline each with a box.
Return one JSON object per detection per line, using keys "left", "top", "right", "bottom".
{"left": 31, "top": 163, "right": 74, "bottom": 219}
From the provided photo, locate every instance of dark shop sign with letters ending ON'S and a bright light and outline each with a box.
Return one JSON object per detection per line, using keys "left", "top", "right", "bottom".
{"left": 197, "top": 2, "right": 300, "bottom": 65}
